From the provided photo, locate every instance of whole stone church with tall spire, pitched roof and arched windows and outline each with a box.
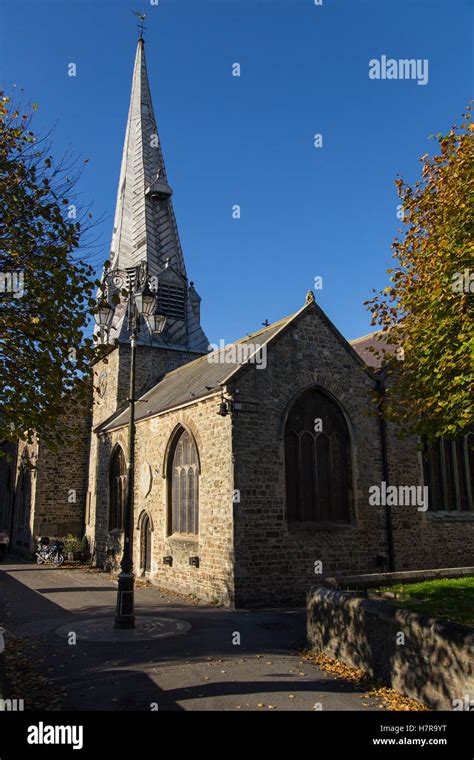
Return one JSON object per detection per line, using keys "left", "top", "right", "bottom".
{"left": 0, "top": 39, "right": 474, "bottom": 607}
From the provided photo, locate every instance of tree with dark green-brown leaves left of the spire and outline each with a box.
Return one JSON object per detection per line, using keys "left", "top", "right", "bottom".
{"left": 0, "top": 92, "right": 96, "bottom": 449}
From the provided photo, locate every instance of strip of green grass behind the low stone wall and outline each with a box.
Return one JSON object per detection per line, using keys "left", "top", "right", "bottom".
{"left": 378, "top": 577, "right": 474, "bottom": 627}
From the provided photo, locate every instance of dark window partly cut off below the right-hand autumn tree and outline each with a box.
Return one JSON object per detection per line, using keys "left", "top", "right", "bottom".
{"left": 423, "top": 432, "right": 474, "bottom": 512}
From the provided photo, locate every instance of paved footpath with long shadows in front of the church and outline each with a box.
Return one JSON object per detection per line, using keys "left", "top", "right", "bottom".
{"left": 0, "top": 562, "right": 381, "bottom": 711}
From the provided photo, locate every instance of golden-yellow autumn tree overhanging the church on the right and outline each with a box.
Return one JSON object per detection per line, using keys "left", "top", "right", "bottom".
{"left": 365, "top": 106, "right": 474, "bottom": 440}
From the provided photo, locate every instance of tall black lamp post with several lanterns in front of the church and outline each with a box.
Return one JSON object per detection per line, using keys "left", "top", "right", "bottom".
{"left": 95, "top": 268, "right": 166, "bottom": 629}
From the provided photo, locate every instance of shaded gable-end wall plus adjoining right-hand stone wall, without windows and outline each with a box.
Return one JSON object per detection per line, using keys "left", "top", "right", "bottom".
{"left": 233, "top": 304, "right": 474, "bottom": 606}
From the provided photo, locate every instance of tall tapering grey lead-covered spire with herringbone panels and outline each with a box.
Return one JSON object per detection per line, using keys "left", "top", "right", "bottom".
{"left": 110, "top": 37, "right": 209, "bottom": 351}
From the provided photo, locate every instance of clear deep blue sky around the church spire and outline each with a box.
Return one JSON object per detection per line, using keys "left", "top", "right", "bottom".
{"left": 0, "top": 0, "right": 473, "bottom": 342}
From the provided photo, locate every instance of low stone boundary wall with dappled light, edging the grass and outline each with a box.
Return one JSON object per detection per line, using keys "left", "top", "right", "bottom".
{"left": 307, "top": 586, "right": 474, "bottom": 710}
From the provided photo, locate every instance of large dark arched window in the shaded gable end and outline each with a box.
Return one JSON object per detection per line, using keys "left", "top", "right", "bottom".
{"left": 285, "top": 388, "right": 352, "bottom": 523}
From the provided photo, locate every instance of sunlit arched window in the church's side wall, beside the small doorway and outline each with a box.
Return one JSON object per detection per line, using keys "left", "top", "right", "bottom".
{"left": 168, "top": 428, "right": 199, "bottom": 535}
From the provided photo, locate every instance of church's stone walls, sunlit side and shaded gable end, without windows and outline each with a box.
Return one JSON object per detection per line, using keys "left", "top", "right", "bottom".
{"left": 86, "top": 307, "right": 474, "bottom": 607}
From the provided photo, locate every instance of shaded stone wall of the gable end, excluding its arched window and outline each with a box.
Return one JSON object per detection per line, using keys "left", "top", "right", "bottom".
{"left": 233, "top": 307, "right": 387, "bottom": 606}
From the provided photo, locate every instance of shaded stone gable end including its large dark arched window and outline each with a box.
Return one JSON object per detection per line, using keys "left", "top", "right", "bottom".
{"left": 228, "top": 296, "right": 386, "bottom": 605}
